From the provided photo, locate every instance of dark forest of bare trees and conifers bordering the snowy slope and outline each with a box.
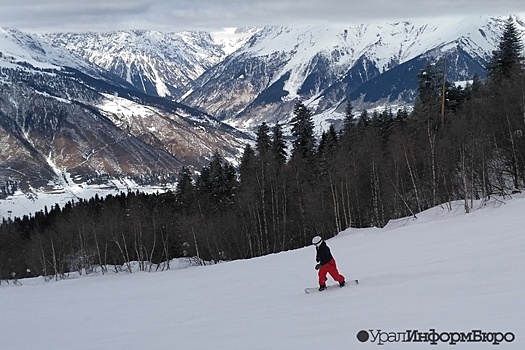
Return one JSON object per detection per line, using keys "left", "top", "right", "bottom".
{"left": 0, "top": 19, "right": 525, "bottom": 279}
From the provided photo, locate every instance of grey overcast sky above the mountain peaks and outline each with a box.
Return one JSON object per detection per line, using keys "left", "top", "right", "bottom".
{"left": 0, "top": 0, "right": 525, "bottom": 32}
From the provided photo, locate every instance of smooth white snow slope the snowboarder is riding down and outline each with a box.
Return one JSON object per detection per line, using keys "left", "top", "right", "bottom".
{"left": 0, "top": 195, "right": 525, "bottom": 350}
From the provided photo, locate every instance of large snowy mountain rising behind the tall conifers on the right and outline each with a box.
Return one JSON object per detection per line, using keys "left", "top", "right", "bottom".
{"left": 183, "top": 17, "right": 525, "bottom": 129}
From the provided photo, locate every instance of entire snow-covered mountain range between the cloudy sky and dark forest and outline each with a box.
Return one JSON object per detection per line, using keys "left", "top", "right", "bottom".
{"left": 0, "top": 17, "right": 525, "bottom": 197}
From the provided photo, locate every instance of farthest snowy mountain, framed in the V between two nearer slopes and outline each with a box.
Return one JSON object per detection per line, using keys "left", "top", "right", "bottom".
{"left": 42, "top": 28, "right": 257, "bottom": 99}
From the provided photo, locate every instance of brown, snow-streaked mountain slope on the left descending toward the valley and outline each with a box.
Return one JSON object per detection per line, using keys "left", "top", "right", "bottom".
{"left": 0, "top": 29, "right": 249, "bottom": 196}
